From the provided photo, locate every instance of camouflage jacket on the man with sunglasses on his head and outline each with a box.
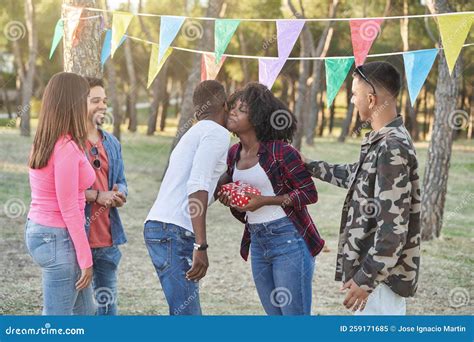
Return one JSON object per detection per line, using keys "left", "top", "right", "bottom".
{"left": 306, "top": 116, "right": 421, "bottom": 297}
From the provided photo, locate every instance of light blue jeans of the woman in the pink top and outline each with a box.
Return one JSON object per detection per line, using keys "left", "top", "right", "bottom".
{"left": 25, "top": 220, "right": 96, "bottom": 315}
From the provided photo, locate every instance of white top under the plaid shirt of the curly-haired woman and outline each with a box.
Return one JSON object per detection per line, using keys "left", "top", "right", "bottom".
{"left": 232, "top": 163, "right": 286, "bottom": 223}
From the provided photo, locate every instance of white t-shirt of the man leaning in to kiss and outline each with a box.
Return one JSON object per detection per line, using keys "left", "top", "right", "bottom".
{"left": 145, "top": 120, "right": 230, "bottom": 232}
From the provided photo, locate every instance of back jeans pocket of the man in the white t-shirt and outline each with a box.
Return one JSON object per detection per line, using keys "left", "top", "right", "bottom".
{"left": 144, "top": 229, "right": 172, "bottom": 272}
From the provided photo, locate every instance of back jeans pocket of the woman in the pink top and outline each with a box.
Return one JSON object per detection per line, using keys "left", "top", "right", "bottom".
{"left": 26, "top": 233, "right": 56, "bottom": 267}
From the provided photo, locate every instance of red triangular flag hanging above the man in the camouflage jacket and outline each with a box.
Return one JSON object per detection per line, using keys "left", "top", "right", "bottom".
{"left": 350, "top": 19, "right": 383, "bottom": 66}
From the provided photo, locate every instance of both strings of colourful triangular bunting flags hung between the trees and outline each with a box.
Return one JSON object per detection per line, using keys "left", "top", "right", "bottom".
{"left": 50, "top": 5, "right": 474, "bottom": 106}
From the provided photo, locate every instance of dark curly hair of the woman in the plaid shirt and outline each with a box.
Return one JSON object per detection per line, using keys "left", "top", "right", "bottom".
{"left": 228, "top": 82, "right": 297, "bottom": 143}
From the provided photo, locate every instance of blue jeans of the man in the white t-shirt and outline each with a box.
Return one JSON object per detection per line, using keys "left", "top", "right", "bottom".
{"left": 143, "top": 221, "right": 202, "bottom": 315}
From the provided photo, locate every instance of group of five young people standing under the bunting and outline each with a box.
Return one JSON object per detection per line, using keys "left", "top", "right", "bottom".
{"left": 25, "top": 62, "right": 420, "bottom": 315}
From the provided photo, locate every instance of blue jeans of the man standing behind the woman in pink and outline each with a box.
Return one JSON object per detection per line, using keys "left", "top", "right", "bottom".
{"left": 92, "top": 246, "right": 122, "bottom": 316}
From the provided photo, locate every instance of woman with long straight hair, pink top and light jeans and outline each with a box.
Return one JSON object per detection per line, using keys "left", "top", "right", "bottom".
{"left": 25, "top": 72, "right": 95, "bottom": 315}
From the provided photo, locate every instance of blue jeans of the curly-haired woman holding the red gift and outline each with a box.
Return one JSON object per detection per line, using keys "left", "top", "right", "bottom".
{"left": 249, "top": 217, "right": 315, "bottom": 315}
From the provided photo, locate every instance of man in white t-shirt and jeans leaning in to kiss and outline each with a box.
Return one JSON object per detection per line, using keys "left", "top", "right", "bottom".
{"left": 144, "top": 81, "right": 230, "bottom": 315}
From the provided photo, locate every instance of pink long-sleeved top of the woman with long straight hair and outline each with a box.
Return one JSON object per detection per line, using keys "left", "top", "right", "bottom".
{"left": 28, "top": 135, "right": 95, "bottom": 269}
